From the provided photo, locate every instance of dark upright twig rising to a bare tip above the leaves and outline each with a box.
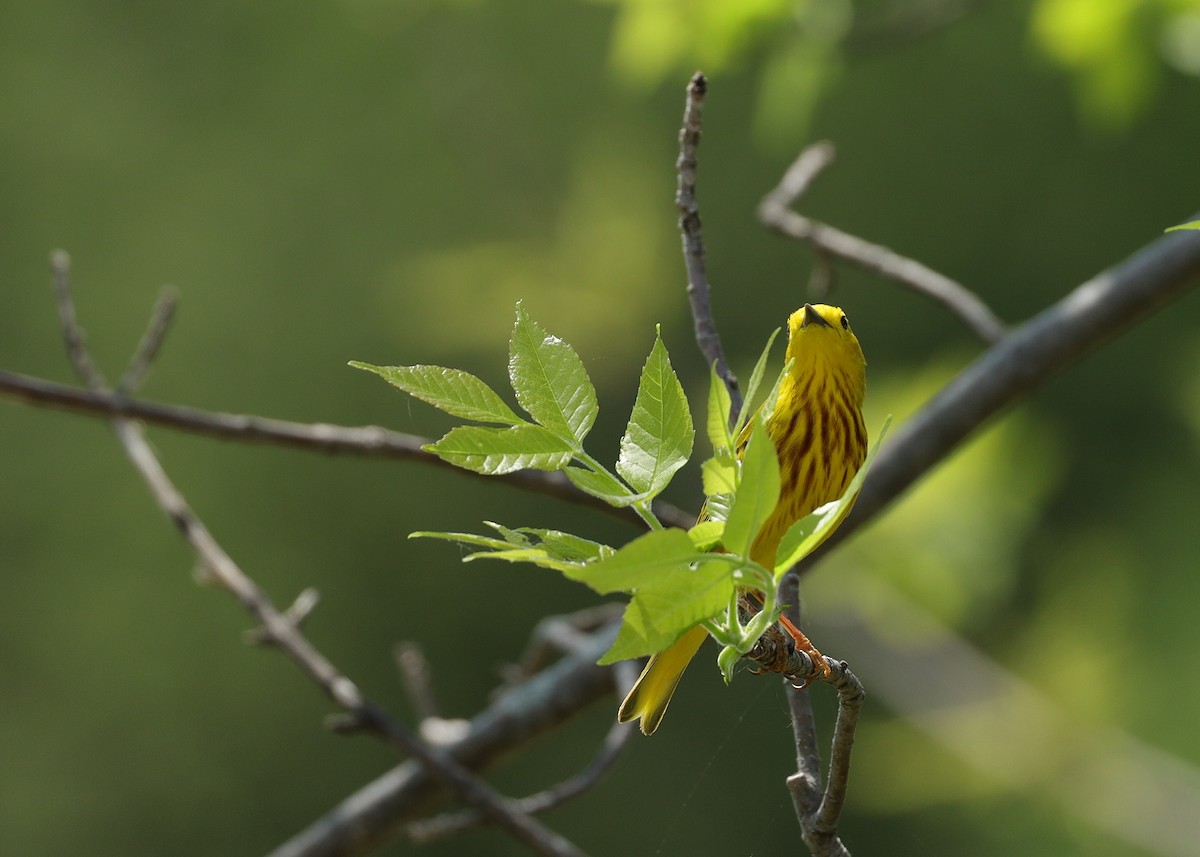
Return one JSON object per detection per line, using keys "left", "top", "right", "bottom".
{"left": 676, "top": 72, "right": 742, "bottom": 419}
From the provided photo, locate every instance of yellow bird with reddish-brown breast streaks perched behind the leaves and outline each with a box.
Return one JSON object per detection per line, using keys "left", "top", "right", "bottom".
{"left": 617, "top": 304, "right": 866, "bottom": 735}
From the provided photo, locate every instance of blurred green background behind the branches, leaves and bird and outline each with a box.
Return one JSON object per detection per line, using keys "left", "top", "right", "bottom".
{"left": 0, "top": 0, "right": 1200, "bottom": 856}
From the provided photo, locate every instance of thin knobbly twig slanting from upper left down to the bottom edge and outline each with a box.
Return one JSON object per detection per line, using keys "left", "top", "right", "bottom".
{"left": 54, "top": 253, "right": 583, "bottom": 857}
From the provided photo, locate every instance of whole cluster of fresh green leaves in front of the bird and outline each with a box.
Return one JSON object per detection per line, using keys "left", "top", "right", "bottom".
{"left": 350, "top": 302, "right": 878, "bottom": 681}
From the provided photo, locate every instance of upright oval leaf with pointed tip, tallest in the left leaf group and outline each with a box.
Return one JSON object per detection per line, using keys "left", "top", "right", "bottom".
{"left": 509, "top": 302, "right": 599, "bottom": 449}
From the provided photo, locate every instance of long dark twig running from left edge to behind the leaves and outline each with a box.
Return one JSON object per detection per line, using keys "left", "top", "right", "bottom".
{"left": 0, "top": 370, "right": 696, "bottom": 527}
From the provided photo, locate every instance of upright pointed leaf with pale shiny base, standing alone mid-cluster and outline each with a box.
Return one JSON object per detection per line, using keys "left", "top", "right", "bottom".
{"left": 617, "top": 331, "right": 695, "bottom": 497}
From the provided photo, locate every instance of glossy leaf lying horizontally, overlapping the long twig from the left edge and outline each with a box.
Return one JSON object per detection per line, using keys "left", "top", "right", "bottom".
{"left": 422, "top": 424, "right": 575, "bottom": 477}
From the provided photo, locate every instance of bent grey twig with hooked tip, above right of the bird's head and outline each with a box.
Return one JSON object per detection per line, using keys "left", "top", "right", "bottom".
{"left": 758, "top": 142, "right": 1006, "bottom": 344}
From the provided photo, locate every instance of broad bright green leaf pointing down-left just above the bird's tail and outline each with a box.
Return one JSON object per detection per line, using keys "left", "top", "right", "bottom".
{"left": 600, "top": 559, "right": 733, "bottom": 664}
